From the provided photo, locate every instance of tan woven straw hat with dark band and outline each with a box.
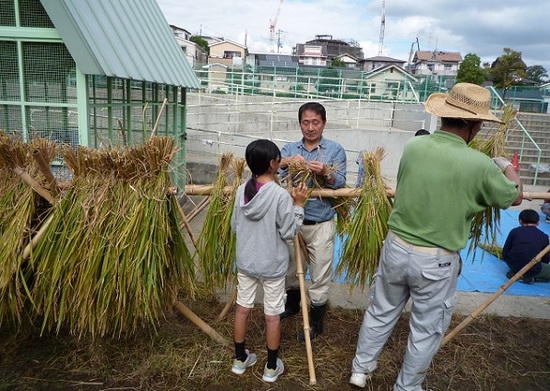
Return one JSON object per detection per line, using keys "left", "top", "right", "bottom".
{"left": 426, "top": 83, "right": 502, "bottom": 123}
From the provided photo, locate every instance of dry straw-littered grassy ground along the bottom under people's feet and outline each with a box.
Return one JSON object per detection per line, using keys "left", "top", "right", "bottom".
{"left": 0, "top": 299, "right": 550, "bottom": 391}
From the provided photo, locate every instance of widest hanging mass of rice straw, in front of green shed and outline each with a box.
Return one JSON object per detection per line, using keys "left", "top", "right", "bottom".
{"left": 31, "top": 137, "right": 194, "bottom": 336}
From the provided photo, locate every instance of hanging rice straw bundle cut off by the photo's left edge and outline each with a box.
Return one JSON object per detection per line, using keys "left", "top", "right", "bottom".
{"left": 0, "top": 134, "right": 57, "bottom": 324}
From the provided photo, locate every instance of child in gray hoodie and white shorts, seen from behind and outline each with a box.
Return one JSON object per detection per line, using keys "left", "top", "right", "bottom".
{"left": 231, "top": 139, "right": 307, "bottom": 382}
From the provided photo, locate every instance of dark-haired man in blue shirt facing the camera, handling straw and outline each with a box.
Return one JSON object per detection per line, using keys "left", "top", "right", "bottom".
{"left": 279, "top": 102, "right": 347, "bottom": 340}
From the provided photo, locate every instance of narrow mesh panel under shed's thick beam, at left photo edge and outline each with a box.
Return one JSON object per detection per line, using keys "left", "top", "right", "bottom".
{"left": 0, "top": 41, "right": 21, "bottom": 101}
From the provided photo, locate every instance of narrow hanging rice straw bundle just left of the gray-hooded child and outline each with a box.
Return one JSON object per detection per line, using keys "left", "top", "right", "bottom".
{"left": 196, "top": 153, "right": 235, "bottom": 293}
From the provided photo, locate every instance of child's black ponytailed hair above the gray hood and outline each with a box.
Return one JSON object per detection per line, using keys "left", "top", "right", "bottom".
{"left": 244, "top": 139, "right": 281, "bottom": 201}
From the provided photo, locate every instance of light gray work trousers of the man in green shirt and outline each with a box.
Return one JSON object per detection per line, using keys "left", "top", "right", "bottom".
{"left": 352, "top": 231, "right": 461, "bottom": 391}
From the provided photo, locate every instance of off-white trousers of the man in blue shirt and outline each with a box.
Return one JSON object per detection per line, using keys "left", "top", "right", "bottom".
{"left": 286, "top": 219, "right": 336, "bottom": 305}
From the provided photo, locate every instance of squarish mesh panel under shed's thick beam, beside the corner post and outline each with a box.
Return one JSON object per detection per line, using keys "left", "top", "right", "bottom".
{"left": 23, "top": 42, "right": 76, "bottom": 103}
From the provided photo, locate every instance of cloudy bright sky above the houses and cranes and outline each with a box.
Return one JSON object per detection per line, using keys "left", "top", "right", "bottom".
{"left": 157, "top": 0, "right": 550, "bottom": 75}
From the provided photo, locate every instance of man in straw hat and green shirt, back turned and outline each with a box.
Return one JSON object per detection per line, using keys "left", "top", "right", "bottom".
{"left": 350, "top": 83, "right": 523, "bottom": 391}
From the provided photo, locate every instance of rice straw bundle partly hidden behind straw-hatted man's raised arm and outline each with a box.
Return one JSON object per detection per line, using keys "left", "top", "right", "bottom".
{"left": 468, "top": 105, "right": 517, "bottom": 254}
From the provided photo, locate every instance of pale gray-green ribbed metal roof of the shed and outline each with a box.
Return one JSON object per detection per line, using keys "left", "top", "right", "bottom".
{"left": 40, "top": 0, "right": 200, "bottom": 88}
